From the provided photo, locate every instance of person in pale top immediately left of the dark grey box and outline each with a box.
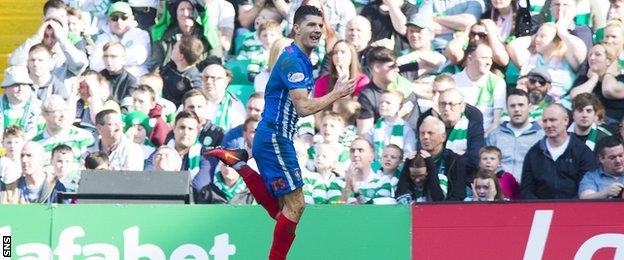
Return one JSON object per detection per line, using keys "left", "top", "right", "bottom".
{"left": 52, "top": 144, "right": 80, "bottom": 192}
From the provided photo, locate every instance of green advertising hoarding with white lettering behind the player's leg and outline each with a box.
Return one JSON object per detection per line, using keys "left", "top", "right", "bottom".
{"left": 0, "top": 205, "right": 411, "bottom": 260}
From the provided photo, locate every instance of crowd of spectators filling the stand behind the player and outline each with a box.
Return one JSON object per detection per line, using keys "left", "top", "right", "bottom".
{"left": 0, "top": 0, "right": 624, "bottom": 204}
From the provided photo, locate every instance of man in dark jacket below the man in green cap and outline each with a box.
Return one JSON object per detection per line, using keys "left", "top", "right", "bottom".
{"left": 100, "top": 41, "right": 138, "bottom": 103}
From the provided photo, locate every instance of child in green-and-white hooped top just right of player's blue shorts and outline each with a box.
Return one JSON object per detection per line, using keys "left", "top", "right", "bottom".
{"left": 303, "top": 144, "right": 345, "bottom": 204}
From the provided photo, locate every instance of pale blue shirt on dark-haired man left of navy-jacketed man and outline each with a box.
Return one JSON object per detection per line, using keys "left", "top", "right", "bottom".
{"left": 485, "top": 122, "right": 544, "bottom": 182}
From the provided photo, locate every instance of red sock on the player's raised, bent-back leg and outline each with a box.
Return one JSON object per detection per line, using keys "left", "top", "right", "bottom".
{"left": 238, "top": 165, "right": 280, "bottom": 219}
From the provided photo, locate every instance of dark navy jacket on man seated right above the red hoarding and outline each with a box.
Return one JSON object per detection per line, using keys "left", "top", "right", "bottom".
{"left": 520, "top": 135, "right": 598, "bottom": 199}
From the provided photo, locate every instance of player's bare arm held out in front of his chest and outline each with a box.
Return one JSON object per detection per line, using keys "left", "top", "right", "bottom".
{"left": 289, "top": 73, "right": 355, "bottom": 117}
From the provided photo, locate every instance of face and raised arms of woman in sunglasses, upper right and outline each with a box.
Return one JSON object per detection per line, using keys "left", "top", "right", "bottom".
{"left": 444, "top": 19, "right": 509, "bottom": 75}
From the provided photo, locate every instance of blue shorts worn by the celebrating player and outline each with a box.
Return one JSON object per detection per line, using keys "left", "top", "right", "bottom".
{"left": 252, "top": 129, "right": 303, "bottom": 197}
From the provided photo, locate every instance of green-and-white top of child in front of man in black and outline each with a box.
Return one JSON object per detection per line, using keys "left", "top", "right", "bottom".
{"left": 373, "top": 118, "right": 405, "bottom": 161}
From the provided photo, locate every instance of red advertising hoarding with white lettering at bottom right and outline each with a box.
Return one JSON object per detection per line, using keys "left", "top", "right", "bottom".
{"left": 412, "top": 202, "right": 624, "bottom": 260}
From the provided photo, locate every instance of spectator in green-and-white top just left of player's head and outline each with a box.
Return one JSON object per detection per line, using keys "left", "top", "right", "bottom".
{"left": 236, "top": 20, "right": 283, "bottom": 82}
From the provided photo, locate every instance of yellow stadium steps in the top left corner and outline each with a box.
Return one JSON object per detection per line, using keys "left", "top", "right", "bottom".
{"left": 0, "top": 0, "right": 45, "bottom": 81}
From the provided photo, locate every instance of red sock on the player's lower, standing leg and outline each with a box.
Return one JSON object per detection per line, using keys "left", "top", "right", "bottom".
{"left": 269, "top": 214, "right": 297, "bottom": 260}
